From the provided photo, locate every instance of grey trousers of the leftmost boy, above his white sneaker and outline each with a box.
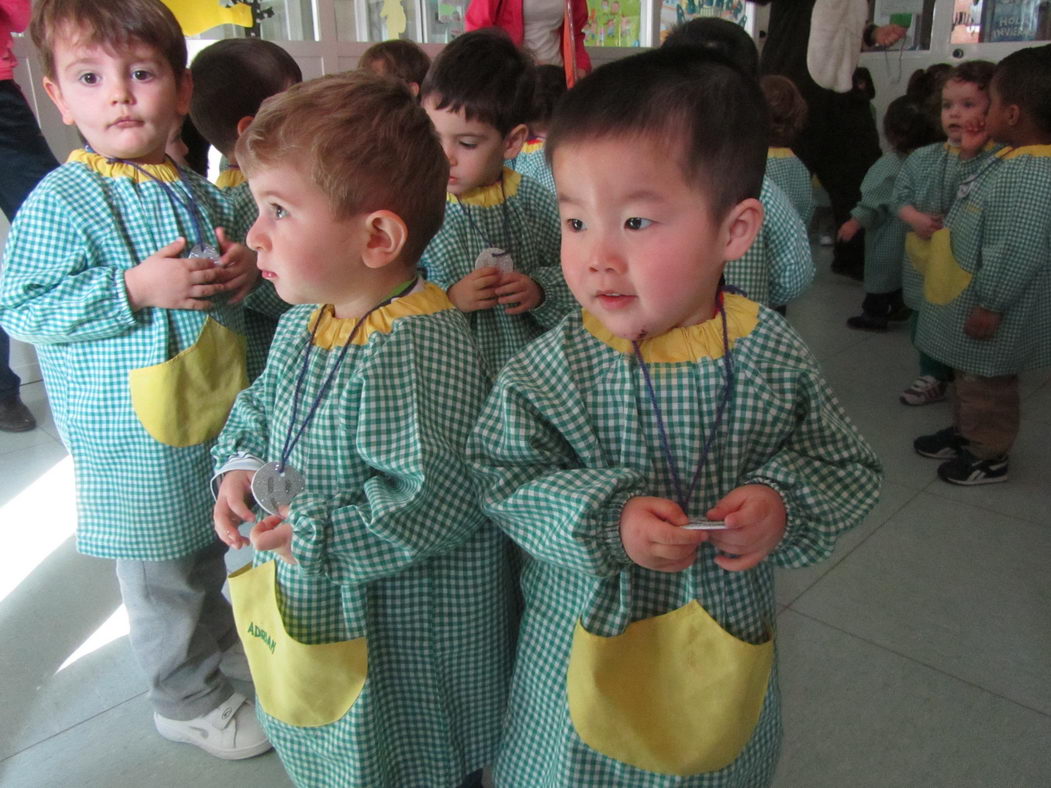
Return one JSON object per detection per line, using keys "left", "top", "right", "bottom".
{"left": 117, "top": 540, "right": 238, "bottom": 720}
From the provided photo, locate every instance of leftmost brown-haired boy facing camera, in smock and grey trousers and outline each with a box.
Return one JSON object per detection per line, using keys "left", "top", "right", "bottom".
{"left": 0, "top": 0, "right": 270, "bottom": 759}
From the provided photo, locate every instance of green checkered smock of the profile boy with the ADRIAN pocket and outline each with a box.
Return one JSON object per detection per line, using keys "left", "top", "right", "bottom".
{"left": 214, "top": 284, "right": 515, "bottom": 788}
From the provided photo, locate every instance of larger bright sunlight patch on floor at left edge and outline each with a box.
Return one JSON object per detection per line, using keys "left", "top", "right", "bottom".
{"left": 0, "top": 456, "right": 77, "bottom": 600}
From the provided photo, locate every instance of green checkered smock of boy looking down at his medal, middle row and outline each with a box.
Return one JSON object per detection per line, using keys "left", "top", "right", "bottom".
{"left": 419, "top": 169, "right": 576, "bottom": 377}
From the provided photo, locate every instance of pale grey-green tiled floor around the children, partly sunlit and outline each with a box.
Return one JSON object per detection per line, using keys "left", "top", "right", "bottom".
{"left": 0, "top": 245, "right": 1051, "bottom": 788}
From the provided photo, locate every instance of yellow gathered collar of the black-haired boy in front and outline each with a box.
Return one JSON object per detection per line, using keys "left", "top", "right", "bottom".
{"left": 583, "top": 293, "right": 759, "bottom": 364}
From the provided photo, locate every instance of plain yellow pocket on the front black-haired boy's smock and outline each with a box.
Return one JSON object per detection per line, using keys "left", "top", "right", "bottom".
{"left": 566, "top": 600, "right": 774, "bottom": 776}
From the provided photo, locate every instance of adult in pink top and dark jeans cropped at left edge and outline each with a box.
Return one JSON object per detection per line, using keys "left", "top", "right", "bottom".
{"left": 0, "top": 0, "right": 58, "bottom": 432}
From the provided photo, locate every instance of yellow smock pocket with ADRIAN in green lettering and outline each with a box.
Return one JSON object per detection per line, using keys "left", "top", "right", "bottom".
{"left": 230, "top": 561, "right": 369, "bottom": 728}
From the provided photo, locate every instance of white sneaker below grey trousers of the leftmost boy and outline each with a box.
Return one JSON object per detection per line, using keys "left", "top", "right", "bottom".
{"left": 153, "top": 692, "right": 270, "bottom": 761}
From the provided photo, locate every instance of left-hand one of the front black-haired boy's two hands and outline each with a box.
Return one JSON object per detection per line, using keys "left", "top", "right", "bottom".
{"left": 620, "top": 497, "right": 708, "bottom": 572}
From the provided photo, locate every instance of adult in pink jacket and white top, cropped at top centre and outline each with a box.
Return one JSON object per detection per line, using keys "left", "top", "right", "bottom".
{"left": 466, "top": 0, "right": 591, "bottom": 76}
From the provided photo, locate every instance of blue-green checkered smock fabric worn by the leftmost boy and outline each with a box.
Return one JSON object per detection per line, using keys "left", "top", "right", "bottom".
{"left": 0, "top": 151, "right": 244, "bottom": 561}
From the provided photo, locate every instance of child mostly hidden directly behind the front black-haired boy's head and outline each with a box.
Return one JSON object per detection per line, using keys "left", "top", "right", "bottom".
{"left": 662, "top": 18, "right": 813, "bottom": 313}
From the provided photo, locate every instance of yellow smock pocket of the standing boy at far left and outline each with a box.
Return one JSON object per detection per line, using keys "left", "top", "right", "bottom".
{"left": 128, "top": 317, "right": 248, "bottom": 447}
